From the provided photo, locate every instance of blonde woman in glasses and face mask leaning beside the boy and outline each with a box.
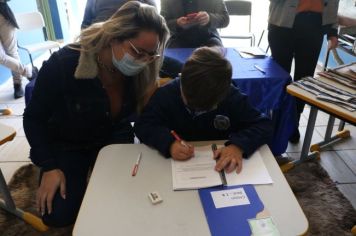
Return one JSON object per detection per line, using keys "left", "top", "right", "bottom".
{"left": 24, "top": 1, "right": 168, "bottom": 227}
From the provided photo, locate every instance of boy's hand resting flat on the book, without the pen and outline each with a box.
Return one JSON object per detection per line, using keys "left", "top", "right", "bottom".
{"left": 214, "top": 144, "right": 243, "bottom": 173}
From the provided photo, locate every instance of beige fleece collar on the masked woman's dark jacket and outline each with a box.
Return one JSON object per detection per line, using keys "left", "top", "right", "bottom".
{"left": 74, "top": 51, "right": 98, "bottom": 79}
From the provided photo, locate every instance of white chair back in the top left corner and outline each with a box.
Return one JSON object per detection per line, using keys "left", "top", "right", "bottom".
{"left": 16, "top": 11, "right": 45, "bottom": 31}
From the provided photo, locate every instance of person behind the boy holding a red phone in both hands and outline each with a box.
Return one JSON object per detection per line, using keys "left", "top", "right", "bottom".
{"left": 161, "top": 0, "right": 230, "bottom": 48}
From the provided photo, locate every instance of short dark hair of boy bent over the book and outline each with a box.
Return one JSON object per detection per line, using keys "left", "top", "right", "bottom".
{"left": 181, "top": 47, "right": 232, "bottom": 110}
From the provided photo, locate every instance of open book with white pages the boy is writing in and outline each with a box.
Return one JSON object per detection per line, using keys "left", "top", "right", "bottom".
{"left": 172, "top": 146, "right": 273, "bottom": 190}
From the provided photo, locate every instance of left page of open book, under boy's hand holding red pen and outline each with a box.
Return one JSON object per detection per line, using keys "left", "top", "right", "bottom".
{"left": 172, "top": 146, "right": 222, "bottom": 190}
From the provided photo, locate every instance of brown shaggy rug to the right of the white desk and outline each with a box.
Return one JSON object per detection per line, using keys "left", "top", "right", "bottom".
{"left": 285, "top": 161, "right": 356, "bottom": 236}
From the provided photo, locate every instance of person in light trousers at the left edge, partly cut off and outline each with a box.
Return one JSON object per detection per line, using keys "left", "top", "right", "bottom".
{"left": 0, "top": 0, "right": 37, "bottom": 99}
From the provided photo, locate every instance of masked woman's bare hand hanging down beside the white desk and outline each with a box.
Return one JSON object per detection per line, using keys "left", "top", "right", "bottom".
{"left": 36, "top": 169, "right": 66, "bottom": 215}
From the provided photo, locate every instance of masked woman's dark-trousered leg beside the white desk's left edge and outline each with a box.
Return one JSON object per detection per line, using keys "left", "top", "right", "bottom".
{"left": 42, "top": 152, "right": 96, "bottom": 227}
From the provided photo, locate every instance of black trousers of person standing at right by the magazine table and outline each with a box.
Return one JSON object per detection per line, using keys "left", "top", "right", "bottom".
{"left": 268, "top": 12, "right": 323, "bottom": 123}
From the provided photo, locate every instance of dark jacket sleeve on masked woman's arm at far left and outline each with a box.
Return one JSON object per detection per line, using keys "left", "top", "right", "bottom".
{"left": 23, "top": 53, "right": 61, "bottom": 171}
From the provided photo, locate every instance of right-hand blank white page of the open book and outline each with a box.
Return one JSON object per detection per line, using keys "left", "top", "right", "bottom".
{"left": 225, "top": 150, "right": 273, "bottom": 186}
